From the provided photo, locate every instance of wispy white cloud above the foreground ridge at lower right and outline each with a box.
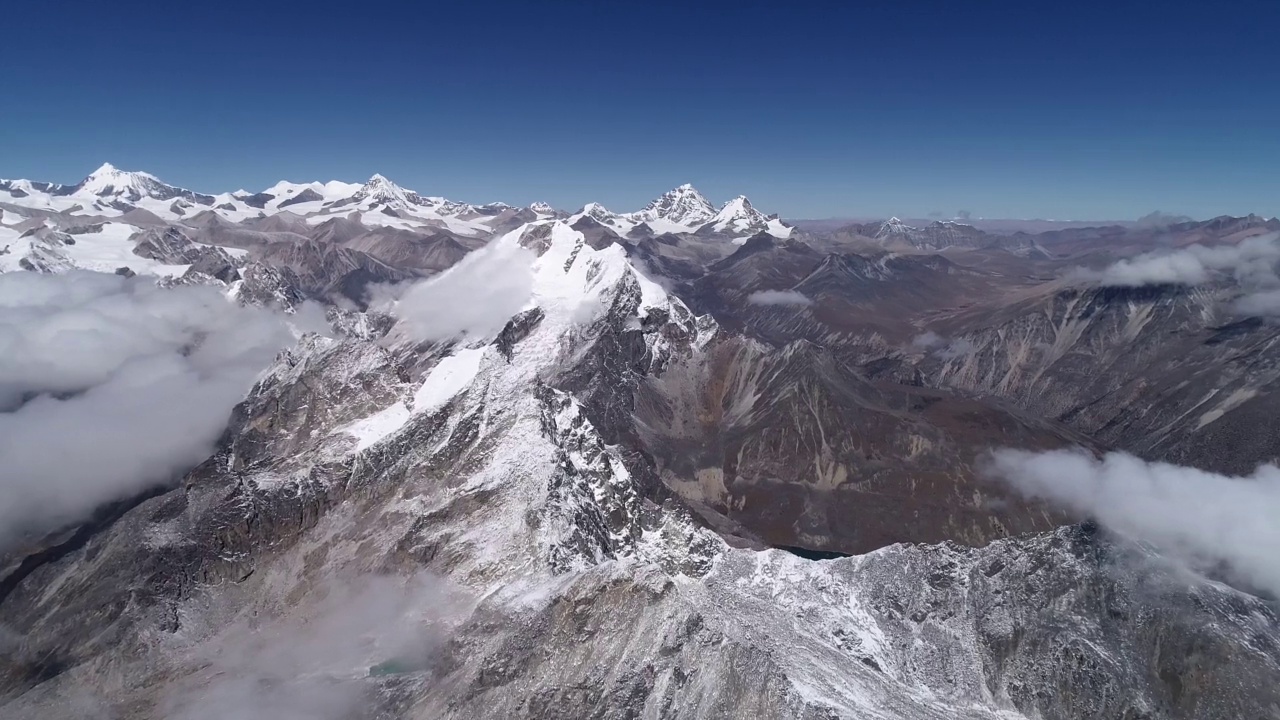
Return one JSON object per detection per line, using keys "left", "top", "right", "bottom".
{"left": 989, "top": 450, "right": 1280, "bottom": 596}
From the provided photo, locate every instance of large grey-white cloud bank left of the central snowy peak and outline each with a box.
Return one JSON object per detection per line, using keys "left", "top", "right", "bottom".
{"left": 0, "top": 272, "right": 293, "bottom": 539}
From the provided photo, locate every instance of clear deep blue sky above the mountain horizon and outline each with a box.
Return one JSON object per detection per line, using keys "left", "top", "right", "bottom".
{"left": 0, "top": 0, "right": 1280, "bottom": 219}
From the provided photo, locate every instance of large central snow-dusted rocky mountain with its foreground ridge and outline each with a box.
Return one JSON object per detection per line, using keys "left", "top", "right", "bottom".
{"left": 10, "top": 215, "right": 1280, "bottom": 720}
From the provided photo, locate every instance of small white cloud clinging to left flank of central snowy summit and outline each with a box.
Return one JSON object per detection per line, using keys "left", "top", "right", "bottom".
{"left": 394, "top": 234, "right": 536, "bottom": 341}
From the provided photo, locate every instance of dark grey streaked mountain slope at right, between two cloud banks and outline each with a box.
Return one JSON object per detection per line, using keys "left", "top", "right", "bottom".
{"left": 922, "top": 286, "right": 1280, "bottom": 474}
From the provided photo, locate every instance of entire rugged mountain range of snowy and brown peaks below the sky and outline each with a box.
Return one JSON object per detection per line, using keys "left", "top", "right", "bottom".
{"left": 0, "top": 165, "right": 1280, "bottom": 720}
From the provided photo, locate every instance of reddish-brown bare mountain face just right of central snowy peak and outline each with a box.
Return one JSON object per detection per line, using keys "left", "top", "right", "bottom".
{"left": 636, "top": 340, "right": 1088, "bottom": 552}
